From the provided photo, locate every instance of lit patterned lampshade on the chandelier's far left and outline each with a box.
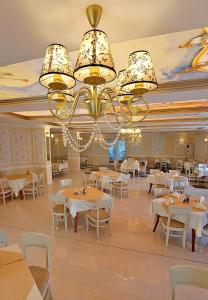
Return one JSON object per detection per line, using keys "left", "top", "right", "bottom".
{"left": 39, "top": 44, "right": 75, "bottom": 90}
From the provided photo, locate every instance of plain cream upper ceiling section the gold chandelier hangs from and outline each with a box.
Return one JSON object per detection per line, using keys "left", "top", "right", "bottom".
{"left": 0, "top": 0, "right": 208, "bottom": 66}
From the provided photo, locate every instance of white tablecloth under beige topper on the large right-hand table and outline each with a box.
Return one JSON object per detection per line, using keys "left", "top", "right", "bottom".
{"left": 152, "top": 198, "right": 208, "bottom": 237}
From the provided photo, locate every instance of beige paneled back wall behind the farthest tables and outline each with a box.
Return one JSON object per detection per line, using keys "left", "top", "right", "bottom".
{"left": 81, "top": 132, "right": 196, "bottom": 166}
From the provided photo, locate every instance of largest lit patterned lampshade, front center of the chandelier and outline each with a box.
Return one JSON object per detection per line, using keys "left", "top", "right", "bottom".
{"left": 74, "top": 29, "right": 116, "bottom": 85}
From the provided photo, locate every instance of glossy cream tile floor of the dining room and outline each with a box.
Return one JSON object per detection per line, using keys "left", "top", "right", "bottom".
{"left": 0, "top": 173, "right": 208, "bottom": 300}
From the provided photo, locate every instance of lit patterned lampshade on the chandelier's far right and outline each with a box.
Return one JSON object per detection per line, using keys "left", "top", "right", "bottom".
{"left": 122, "top": 50, "right": 157, "bottom": 95}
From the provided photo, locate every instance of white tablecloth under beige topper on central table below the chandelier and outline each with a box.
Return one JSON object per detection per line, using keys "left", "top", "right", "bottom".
{"left": 58, "top": 190, "right": 113, "bottom": 218}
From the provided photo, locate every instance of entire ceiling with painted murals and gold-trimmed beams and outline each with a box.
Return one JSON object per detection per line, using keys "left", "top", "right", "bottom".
{"left": 0, "top": 0, "right": 208, "bottom": 131}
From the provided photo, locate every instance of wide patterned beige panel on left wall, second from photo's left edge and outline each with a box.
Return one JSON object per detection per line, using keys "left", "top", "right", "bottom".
{"left": 11, "top": 129, "right": 32, "bottom": 163}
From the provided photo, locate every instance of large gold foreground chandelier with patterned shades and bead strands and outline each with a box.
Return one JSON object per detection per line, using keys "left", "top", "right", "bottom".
{"left": 39, "top": 4, "right": 157, "bottom": 152}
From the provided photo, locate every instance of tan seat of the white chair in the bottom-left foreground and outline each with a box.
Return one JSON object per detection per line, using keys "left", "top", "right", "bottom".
{"left": 29, "top": 266, "right": 49, "bottom": 295}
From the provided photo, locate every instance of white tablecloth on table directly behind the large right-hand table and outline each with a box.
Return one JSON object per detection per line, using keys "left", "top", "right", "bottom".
{"left": 147, "top": 173, "right": 189, "bottom": 192}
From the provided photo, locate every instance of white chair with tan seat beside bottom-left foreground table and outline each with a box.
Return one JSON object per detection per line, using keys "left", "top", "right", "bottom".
{"left": 21, "top": 232, "right": 52, "bottom": 299}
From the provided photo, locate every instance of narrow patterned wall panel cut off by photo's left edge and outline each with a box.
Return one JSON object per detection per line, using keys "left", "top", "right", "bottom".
{"left": 0, "top": 128, "right": 12, "bottom": 166}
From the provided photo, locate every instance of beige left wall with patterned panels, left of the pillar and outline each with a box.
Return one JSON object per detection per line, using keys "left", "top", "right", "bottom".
{"left": 0, "top": 125, "right": 46, "bottom": 172}
